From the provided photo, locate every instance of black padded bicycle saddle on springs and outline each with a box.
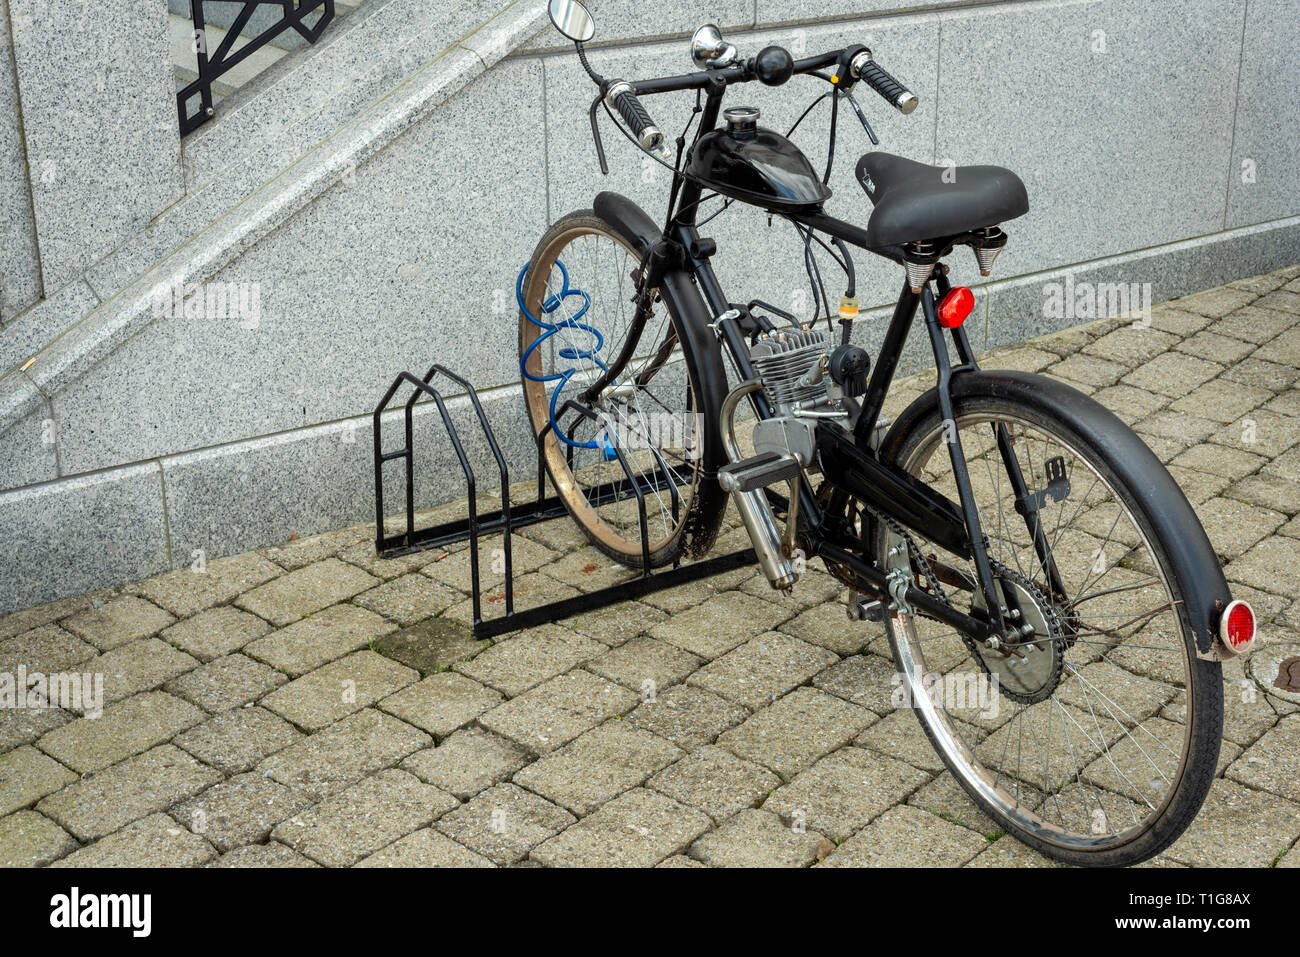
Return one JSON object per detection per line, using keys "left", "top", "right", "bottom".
{"left": 858, "top": 152, "right": 1030, "bottom": 246}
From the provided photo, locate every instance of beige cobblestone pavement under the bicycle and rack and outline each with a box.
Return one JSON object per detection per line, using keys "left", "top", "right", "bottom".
{"left": 0, "top": 267, "right": 1300, "bottom": 867}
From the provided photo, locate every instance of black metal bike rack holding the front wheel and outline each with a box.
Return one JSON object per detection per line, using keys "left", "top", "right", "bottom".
{"left": 374, "top": 363, "right": 758, "bottom": 638}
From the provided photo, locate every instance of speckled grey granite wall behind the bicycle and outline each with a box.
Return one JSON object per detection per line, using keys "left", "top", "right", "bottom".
{"left": 0, "top": 0, "right": 1300, "bottom": 612}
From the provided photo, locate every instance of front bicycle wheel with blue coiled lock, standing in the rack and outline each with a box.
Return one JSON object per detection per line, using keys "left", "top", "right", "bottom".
{"left": 517, "top": 211, "right": 725, "bottom": 567}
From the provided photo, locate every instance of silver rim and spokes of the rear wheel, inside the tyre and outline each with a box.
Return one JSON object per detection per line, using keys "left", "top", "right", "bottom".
{"left": 884, "top": 412, "right": 1192, "bottom": 850}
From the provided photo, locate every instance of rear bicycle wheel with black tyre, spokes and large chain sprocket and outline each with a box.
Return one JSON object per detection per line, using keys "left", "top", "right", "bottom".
{"left": 876, "top": 382, "right": 1223, "bottom": 866}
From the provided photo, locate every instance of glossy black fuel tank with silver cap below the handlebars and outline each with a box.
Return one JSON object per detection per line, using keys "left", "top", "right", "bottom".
{"left": 686, "top": 107, "right": 831, "bottom": 211}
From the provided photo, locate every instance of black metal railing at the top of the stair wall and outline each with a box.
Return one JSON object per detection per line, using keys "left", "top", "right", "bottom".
{"left": 176, "top": 0, "right": 334, "bottom": 137}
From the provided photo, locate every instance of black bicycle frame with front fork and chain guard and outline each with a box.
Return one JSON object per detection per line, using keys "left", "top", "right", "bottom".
{"left": 584, "top": 61, "right": 1063, "bottom": 650}
